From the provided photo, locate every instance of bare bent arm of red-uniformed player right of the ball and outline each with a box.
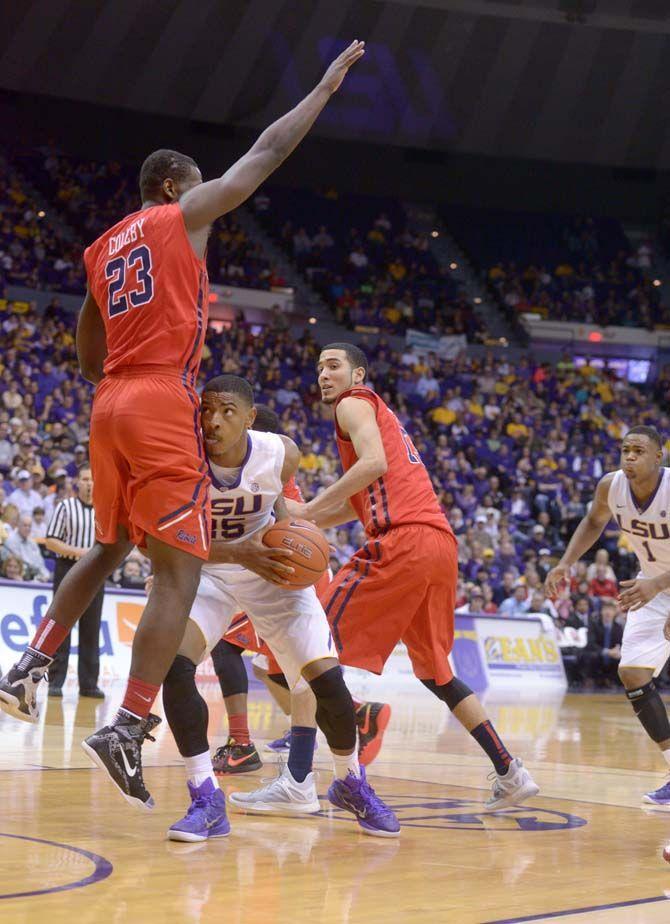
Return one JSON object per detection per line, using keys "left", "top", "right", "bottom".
{"left": 305, "top": 397, "right": 388, "bottom": 526}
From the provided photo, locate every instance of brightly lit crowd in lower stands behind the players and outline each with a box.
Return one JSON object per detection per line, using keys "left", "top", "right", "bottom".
{"left": 0, "top": 286, "right": 670, "bottom": 684}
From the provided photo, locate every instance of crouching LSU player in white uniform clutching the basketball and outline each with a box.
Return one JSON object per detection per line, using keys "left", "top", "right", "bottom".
{"left": 163, "top": 375, "right": 400, "bottom": 841}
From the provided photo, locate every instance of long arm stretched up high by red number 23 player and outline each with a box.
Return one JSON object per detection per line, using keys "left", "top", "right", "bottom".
{"left": 180, "top": 41, "right": 365, "bottom": 232}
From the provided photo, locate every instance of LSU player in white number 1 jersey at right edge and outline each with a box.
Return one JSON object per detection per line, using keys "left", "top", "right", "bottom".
{"left": 546, "top": 426, "right": 670, "bottom": 808}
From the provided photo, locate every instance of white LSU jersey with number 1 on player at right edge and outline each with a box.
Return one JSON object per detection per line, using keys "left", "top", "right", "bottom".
{"left": 607, "top": 468, "right": 670, "bottom": 577}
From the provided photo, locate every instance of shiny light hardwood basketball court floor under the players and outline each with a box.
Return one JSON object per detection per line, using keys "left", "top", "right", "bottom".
{"left": 0, "top": 681, "right": 670, "bottom": 924}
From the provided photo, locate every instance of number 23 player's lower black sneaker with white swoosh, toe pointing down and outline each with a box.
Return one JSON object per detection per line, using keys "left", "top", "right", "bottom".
{"left": 81, "top": 714, "right": 161, "bottom": 809}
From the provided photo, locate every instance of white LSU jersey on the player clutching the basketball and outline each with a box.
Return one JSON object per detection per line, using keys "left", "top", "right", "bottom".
{"left": 205, "top": 430, "right": 284, "bottom": 571}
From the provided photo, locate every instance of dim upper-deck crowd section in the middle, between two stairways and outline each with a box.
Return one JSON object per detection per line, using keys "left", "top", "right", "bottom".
{"left": 254, "top": 188, "right": 484, "bottom": 342}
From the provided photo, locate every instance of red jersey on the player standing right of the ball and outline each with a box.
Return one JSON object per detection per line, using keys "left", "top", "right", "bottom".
{"left": 335, "top": 386, "right": 452, "bottom": 537}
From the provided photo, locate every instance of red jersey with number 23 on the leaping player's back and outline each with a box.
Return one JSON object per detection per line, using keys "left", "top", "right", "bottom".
{"left": 84, "top": 203, "right": 209, "bottom": 385}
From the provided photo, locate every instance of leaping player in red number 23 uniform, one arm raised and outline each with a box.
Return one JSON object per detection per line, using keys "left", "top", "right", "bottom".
{"left": 0, "top": 41, "right": 364, "bottom": 808}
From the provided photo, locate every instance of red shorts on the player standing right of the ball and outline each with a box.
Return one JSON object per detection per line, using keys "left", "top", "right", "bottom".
{"left": 321, "top": 526, "right": 458, "bottom": 684}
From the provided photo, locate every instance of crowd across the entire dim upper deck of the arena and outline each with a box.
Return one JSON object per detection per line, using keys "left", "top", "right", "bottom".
{"left": 6, "top": 146, "right": 670, "bottom": 342}
